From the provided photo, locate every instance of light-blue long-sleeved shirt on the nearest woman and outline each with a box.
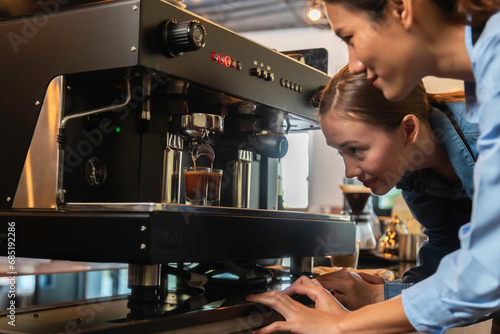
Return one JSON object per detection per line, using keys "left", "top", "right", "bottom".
{"left": 402, "top": 9, "right": 500, "bottom": 333}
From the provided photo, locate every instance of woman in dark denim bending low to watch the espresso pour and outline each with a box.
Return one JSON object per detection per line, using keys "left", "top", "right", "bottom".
{"left": 318, "top": 67, "right": 479, "bottom": 309}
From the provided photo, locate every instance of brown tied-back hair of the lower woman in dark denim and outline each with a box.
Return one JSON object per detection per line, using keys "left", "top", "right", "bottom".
{"left": 318, "top": 66, "right": 464, "bottom": 132}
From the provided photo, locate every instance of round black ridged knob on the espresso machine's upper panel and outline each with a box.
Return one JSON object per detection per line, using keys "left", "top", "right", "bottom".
{"left": 163, "top": 20, "right": 207, "bottom": 57}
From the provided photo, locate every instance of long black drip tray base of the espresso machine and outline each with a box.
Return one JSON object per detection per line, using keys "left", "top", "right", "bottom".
{"left": 0, "top": 203, "right": 356, "bottom": 264}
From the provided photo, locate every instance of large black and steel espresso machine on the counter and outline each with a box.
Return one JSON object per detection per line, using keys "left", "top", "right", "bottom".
{"left": 0, "top": 0, "right": 355, "bottom": 333}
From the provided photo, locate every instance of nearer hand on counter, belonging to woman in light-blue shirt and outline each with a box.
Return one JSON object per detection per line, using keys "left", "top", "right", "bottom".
{"left": 247, "top": 276, "right": 349, "bottom": 334}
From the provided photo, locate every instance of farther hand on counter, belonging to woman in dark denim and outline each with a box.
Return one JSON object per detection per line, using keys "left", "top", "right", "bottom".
{"left": 316, "top": 269, "right": 385, "bottom": 310}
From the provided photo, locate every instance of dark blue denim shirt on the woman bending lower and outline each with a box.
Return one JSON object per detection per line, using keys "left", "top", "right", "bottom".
{"left": 384, "top": 102, "right": 479, "bottom": 299}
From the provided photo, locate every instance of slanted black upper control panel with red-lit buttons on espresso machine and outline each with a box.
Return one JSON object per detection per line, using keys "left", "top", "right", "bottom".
{"left": 139, "top": 0, "right": 329, "bottom": 120}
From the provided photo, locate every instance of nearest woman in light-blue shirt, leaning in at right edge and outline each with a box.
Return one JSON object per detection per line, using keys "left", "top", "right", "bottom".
{"left": 249, "top": 0, "right": 500, "bottom": 333}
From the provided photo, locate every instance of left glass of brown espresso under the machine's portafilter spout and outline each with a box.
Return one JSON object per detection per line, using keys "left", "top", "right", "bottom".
{"left": 184, "top": 167, "right": 210, "bottom": 205}
